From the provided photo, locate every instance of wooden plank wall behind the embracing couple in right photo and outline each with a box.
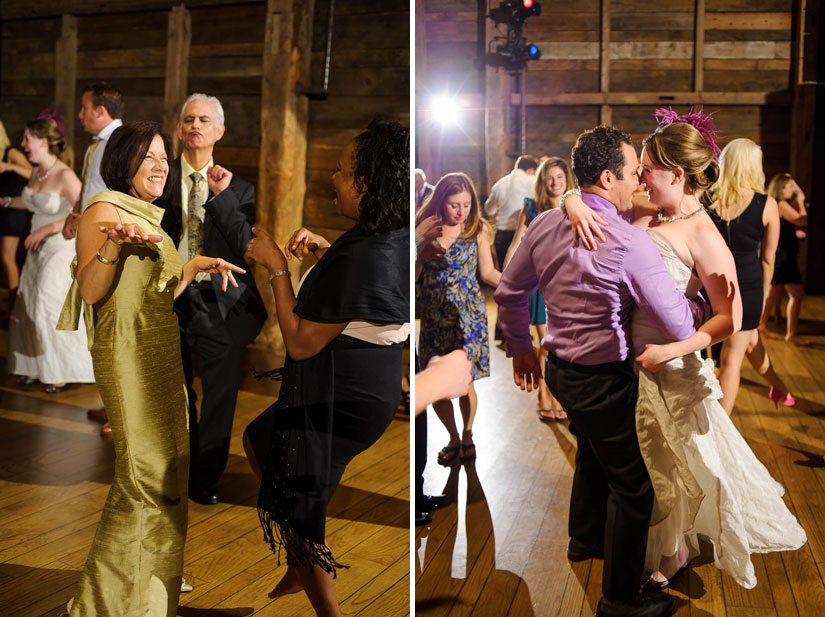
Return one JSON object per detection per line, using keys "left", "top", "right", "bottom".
{"left": 416, "top": 0, "right": 795, "bottom": 199}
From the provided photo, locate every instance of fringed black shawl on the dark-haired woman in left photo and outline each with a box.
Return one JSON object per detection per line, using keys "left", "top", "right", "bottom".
{"left": 258, "top": 226, "right": 410, "bottom": 574}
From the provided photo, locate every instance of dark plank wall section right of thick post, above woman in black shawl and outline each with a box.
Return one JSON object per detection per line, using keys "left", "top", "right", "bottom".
{"left": 304, "top": 0, "right": 410, "bottom": 239}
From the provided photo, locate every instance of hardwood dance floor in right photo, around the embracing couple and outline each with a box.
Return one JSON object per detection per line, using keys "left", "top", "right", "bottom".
{"left": 414, "top": 297, "right": 825, "bottom": 617}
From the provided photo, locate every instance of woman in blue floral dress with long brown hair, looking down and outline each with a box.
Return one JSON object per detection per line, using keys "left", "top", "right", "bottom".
{"left": 416, "top": 173, "right": 501, "bottom": 465}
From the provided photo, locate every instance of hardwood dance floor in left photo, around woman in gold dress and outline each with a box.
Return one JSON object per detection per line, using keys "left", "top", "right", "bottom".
{"left": 0, "top": 320, "right": 410, "bottom": 617}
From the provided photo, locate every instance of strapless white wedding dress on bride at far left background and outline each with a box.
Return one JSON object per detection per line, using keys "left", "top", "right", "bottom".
{"left": 8, "top": 187, "right": 95, "bottom": 384}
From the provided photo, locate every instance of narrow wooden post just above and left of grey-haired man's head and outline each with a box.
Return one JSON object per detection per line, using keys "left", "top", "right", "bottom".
{"left": 163, "top": 4, "right": 192, "bottom": 156}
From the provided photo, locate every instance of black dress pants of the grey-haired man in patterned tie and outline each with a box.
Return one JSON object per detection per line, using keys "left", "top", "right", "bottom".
{"left": 175, "top": 282, "right": 246, "bottom": 492}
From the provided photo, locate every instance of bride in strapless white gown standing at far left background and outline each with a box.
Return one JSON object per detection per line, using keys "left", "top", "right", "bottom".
{"left": 8, "top": 118, "right": 94, "bottom": 384}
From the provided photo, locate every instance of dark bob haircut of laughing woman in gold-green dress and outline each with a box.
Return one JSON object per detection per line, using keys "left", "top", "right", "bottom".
{"left": 100, "top": 120, "right": 175, "bottom": 199}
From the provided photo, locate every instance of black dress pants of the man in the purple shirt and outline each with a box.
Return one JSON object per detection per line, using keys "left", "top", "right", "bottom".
{"left": 545, "top": 352, "right": 654, "bottom": 601}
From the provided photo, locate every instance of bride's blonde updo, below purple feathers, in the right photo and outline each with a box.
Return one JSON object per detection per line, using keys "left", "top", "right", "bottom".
{"left": 642, "top": 122, "right": 719, "bottom": 193}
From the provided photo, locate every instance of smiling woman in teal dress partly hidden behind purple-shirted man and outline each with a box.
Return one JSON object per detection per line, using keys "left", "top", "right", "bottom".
{"left": 504, "top": 156, "right": 576, "bottom": 422}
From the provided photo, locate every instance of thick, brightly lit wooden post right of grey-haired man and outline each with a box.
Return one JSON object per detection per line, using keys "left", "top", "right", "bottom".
{"left": 255, "top": 0, "right": 315, "bottom": 351}
